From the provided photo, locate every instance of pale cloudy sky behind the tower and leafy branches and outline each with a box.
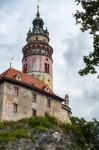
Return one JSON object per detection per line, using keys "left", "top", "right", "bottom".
{"left": 0, "top": 0, "right": 99, "bottom": 120}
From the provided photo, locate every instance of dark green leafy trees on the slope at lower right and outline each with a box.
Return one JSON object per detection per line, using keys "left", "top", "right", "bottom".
{"left": 71, "top": 117, "right": 99, "bottom": 150}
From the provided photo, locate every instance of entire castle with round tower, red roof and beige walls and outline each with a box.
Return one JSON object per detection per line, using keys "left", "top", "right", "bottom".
{"left": 0, "top": 6, "right": 71, "bottom": 122}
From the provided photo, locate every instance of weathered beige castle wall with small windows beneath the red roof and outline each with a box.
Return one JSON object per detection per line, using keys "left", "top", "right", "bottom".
{"left": 2, "top": 82, "right": 70, "bottom": 122}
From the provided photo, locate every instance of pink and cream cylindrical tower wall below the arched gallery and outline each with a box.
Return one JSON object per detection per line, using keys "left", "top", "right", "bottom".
{"left": 23, "top": 55, "right": 53, "bottom": 89}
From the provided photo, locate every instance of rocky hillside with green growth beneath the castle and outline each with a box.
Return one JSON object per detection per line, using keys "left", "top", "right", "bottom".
{"left": 0, "top": 115, "right": 99, "bottom": 150}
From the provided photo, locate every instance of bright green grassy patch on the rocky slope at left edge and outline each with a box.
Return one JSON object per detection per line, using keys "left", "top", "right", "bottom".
{"left": 0, "top": 129, "right": 28, "bottom": 142}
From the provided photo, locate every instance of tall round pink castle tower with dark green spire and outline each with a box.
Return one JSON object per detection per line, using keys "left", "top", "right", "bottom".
{"left": 22, "top": 6, "right": 53, "bottom": 89}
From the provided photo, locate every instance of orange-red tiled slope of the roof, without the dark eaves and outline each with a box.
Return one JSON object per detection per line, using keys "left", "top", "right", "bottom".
{"left": 0, "top": 68, "right": 53, "bottom": 93}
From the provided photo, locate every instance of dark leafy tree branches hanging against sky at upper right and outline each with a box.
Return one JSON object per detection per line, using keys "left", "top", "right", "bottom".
{"left": 74, "top": 0, "right": 99, "bottom": 78}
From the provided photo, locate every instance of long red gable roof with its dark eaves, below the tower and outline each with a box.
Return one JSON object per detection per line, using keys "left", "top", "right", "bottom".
{"left": 0, "top": 68, "right": 71, "bottom": 113}
